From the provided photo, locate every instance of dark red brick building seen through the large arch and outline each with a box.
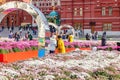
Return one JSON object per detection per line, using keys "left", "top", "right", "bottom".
{"left": 0, "top": 0, "right": 32, "bottom": 27}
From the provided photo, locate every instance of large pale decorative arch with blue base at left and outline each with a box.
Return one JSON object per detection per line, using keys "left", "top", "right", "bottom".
{"left": 0, "top": 1, "right": 49, "bottom": 62}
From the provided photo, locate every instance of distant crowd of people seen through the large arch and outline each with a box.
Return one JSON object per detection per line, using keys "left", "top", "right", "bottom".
{"left": 0, "top": 25, "right": 37, "bottom": 41}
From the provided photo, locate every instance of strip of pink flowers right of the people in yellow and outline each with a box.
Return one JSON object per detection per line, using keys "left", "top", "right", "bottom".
{"left": 65, "top": 41, "right": 117, "bottom": 50}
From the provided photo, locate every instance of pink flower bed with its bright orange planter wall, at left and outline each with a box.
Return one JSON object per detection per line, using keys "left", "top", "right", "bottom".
{"left": 0, "top": 40, "right": 38, "bottom": 63}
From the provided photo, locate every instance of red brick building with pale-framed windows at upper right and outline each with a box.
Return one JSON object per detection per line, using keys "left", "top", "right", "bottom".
{"left": 61, "top": 0, "right": 120, "bottom": 32}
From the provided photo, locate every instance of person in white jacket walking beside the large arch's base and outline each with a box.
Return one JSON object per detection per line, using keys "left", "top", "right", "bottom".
{"left": 48, "top": 35, "right": 57, "bottom": 54}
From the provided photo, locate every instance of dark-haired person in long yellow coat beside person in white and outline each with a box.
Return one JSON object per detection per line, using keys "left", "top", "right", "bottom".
{"left": 57, "top": 35, "right": 65, "bottom": 54}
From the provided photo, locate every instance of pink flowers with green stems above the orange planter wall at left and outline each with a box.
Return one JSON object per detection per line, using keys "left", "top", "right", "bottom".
{"left": 0, "top": 40, "right": 38, "bottom": 54}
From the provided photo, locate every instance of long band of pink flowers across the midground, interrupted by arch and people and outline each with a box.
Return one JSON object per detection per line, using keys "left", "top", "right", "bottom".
{"left": 0, "top": 40, "right": 117, "bottom": 54}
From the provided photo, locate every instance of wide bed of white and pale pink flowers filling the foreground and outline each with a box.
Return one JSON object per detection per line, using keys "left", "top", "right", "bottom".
{"left": 0, "top": 50, "right": 120, "bottom": 80}
